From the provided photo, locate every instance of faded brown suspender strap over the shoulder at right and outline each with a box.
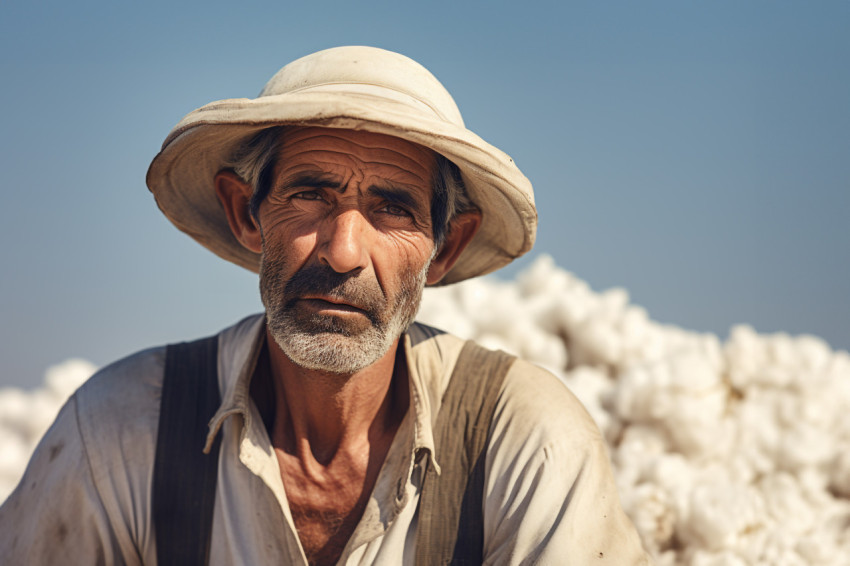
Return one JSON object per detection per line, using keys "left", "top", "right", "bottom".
{"left": 416, "top": 342, "right": 515, "bottom": 566}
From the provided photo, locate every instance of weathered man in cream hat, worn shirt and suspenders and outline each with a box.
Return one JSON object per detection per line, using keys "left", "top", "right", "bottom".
{"left": 0, "top": 47, "right": 647, "bottom": 564}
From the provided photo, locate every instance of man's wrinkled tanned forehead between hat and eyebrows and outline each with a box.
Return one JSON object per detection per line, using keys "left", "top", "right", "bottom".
{"left": 277, "top": 127, "right": 436, "bottom": 189}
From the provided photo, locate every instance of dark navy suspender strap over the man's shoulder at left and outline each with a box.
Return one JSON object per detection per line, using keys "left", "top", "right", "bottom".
{"left": 153, "top": 336, "right": 221, "bottom": 566}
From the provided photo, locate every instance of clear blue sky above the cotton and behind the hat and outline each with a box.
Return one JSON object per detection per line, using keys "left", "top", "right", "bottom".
{"left": 0, "top": 0, "right": 850, "bottom": 386}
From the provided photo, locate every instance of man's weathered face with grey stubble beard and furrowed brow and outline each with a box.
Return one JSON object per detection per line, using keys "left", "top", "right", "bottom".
{"left": 253, "top": 128, "right": 435, "bottom": 373}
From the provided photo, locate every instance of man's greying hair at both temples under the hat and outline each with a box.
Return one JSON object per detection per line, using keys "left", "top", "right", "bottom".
{"left": 223, "top": 126, "right": 478, "bottom": 249}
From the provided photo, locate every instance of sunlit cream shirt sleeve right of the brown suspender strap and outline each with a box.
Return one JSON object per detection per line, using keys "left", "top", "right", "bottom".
{"left": 484, "top": 360, "right": 651, "bottom": 566}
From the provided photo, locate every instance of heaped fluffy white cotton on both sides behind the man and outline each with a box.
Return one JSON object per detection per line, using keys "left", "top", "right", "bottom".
{"left": 0, "top": 257, "right": 850, "bottom": 566}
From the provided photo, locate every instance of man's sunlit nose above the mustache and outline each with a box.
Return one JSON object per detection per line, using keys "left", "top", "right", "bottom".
{"left": 318, "top": 210, "right": 371, "bottom": 273}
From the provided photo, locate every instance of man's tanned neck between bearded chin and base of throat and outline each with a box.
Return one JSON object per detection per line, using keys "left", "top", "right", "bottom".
{"left": 266, "top": 326, "right": 409, "bottom": 466}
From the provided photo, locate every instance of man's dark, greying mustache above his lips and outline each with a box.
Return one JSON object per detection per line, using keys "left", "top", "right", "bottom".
{"left": 283, "top": 264, "right": 387, "bottom": 323}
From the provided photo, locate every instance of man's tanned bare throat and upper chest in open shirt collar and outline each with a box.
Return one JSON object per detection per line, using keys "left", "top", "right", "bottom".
{"left": 251, "top": 341, "right": 410, "bottom": 564}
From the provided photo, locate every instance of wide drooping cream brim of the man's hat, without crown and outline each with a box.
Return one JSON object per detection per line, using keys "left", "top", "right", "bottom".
{"left": 147, "top": 89, "right": 537, "bottom": 283}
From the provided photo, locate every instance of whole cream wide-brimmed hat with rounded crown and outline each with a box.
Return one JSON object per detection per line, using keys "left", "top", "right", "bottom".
{"left": 147, "top": 47, "right": 537, "bottom": 283}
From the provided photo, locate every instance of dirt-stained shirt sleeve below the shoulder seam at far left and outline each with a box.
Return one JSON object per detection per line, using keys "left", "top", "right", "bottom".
{"left": 0, "top": 397, "right": 124, "bottom": 564}
